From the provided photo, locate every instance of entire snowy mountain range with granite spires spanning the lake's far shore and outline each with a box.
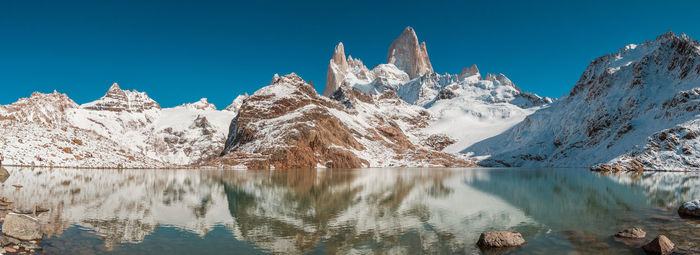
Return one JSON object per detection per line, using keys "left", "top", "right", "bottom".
{"left": 0, "top": 27, "right": 700, "bottom": 170}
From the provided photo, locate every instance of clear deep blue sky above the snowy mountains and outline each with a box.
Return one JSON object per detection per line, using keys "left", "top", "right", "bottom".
{"left": 0, "top": 0, "right": 700, "bottom": 108}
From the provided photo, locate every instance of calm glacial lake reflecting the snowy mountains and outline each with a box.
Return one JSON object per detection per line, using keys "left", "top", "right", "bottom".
{"left": 0, "top": 167, "right": 700, "bottom": 254}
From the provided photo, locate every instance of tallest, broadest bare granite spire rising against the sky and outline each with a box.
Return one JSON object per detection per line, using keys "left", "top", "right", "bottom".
{"left": 386, "top": 27, "right": 433, "bottom": 79}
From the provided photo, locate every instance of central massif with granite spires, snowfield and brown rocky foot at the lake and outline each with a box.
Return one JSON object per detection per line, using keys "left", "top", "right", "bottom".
{"left": 210, "top": 27, "right": 552, "bottom": 168}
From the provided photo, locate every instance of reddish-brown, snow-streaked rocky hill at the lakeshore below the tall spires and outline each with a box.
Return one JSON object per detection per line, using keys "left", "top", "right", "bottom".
{"left": 224, "top": 74, "right": 366, "bottom": 168}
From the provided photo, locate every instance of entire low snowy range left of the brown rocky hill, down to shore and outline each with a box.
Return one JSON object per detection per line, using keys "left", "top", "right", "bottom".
{"left": 0, "top": 83, "right": 235, "bottom": 168}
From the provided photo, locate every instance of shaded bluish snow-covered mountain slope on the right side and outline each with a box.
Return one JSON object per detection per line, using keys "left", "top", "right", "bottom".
{"left": 470, "top": 32, "right": 700, "bottom": 170}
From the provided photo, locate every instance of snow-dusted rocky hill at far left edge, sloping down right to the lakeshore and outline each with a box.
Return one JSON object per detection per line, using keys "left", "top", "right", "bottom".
{"left": 0, "top": 91, "right": 162, "bottom": 167}
